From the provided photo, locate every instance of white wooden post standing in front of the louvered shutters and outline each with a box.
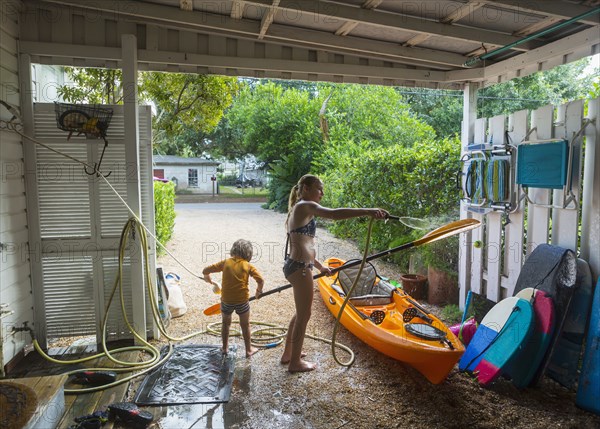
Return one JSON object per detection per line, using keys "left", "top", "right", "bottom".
{"left": 121, "top": 34, "right": 147, "bottom": 339}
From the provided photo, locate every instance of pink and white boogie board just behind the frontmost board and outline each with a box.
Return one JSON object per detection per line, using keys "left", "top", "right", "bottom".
{"left": 504, "top": 288, "right": 555, "bottom": 389}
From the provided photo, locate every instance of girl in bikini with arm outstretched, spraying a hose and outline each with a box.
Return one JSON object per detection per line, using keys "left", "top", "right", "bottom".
{"left": 281, "top": 174, "right": 389, "bottom": 372}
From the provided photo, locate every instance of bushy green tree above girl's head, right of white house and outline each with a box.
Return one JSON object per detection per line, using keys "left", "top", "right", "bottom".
{"left": 210, "top": 82, "right": 322, "bottom": 211}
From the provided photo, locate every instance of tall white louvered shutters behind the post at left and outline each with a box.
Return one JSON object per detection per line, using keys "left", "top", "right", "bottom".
{"left": 34, "top": 104, "right": 155, "bottom": 341}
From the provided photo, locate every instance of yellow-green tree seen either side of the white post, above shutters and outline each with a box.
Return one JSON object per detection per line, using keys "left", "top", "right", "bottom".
{"left": 58, "top": 67, "right": 239, "bottom": 156}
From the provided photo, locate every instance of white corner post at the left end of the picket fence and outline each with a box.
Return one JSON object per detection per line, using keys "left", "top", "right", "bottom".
{"left": 458, "top": 82, "right": 479, "bottom": 310}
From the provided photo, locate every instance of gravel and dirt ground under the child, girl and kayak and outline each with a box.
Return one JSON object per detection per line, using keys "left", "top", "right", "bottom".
{"left": 152, "top": 203, "right": 600, "bottom": 429}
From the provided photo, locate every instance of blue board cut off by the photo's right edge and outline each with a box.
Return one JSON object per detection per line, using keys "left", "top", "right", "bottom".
{"left": 575, "top": 280, "right": 600, "bottom": 415}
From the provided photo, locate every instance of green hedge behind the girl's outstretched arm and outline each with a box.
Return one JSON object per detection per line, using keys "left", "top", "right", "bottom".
{"left": 322, "top": 139, "right": 460, "bottom": 252}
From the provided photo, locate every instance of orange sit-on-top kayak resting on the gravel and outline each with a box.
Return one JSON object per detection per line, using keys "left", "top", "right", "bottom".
{"left": 319, "top": 258, "right": 465, "bottom": 384}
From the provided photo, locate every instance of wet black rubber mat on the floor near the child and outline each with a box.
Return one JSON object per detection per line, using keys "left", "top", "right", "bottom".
{"left": 134, "top": 344, "right": 235, "bottom": 405}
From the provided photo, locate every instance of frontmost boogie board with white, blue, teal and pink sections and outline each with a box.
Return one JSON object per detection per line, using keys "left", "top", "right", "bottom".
{"left": 458, "top": 297, "right": 533, "bottom": 385}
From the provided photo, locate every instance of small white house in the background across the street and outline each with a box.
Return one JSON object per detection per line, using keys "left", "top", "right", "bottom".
{"left": 152, "top": 155, "right": 220, "bottom": 194}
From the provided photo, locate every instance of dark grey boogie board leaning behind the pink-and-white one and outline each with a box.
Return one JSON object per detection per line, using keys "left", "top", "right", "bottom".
{"left": 514, "top": 244, "right": 577, "bottom": 385}
